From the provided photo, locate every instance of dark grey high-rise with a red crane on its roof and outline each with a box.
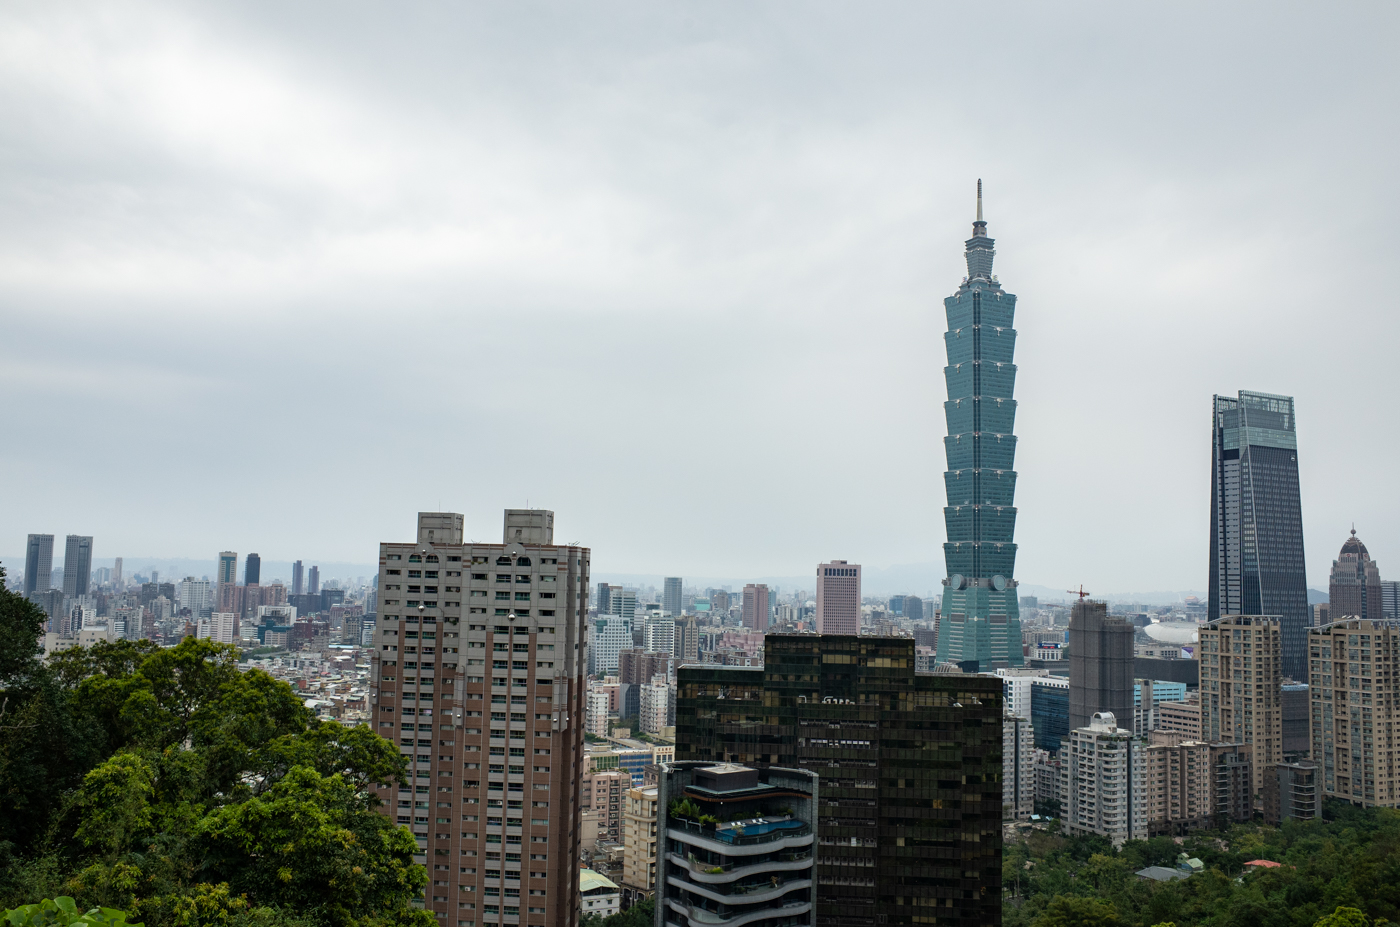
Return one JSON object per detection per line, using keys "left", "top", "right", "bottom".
{"left": 1070, "top": 598, "right": 1135, "bottom": 731}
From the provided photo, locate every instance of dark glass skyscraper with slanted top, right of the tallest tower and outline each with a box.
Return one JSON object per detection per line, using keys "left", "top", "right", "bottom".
{"left": 1210, "top": 389, "right": 1312, "bottom": 681}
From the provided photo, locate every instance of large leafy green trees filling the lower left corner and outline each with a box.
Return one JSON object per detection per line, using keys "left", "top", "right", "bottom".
{"left": 0, "top": 570, "right": 435, "bottom": 927}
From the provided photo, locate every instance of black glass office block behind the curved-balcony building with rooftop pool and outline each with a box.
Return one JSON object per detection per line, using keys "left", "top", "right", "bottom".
{"left": 676, "top": 634, "right": 1002, "bottom": 927}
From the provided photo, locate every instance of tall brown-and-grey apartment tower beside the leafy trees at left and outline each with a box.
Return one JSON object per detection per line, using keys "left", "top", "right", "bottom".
{"left": 371, "top": 510, "right": 589, "bottom": 927}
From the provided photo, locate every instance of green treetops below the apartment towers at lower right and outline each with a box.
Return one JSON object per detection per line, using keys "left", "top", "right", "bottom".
{"left": 1002, "top": 802, "right": 1400, "bottom": 927}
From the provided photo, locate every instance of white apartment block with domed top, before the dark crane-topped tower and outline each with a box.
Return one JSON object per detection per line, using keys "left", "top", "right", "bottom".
{"left": 1060, "top": 711, "right": 1147, "bottom": 847}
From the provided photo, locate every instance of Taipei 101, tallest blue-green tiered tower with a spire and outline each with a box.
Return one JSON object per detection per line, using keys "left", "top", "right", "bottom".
{"left": 937, "top": 181, "right": 1023, "bottom": 671}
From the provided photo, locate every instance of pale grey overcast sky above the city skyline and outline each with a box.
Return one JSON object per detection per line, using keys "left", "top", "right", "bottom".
{"left": 0, "top": 1, "right": 1400, "bottom": 592}
